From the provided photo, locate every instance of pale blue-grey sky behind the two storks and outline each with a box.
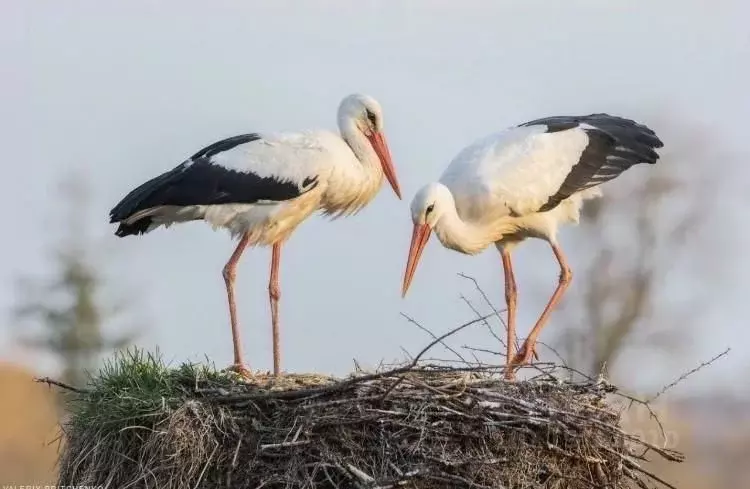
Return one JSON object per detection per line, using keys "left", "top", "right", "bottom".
{"left": 0, "top": 0, "right": 750, "bottom": 396}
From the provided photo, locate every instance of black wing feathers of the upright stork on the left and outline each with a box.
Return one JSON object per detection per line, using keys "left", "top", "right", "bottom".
{"left": 110, "top": 134, "right": 318, "bottom": 236}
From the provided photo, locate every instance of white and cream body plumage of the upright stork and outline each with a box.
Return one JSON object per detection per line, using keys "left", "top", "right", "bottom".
{"left": 151, "top": 131, "right": 383, "bottom": 246}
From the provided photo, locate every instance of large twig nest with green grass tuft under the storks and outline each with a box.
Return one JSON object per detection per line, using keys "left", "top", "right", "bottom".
{"left": 45, "top": 353, "right": 681, "bottom": 489}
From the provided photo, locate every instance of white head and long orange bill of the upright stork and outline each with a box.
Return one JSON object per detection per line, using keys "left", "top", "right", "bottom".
{"left": 338, "top": 93, "right": 401, "bottom": 199}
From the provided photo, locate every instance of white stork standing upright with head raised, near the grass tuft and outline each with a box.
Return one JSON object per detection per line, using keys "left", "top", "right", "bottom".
{"left": 110, "top": 94, "right": 401, "bottom": 375}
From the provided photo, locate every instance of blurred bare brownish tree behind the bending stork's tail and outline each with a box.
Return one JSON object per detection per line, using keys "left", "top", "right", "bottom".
{"left": 556, "top": 118, "right": 721, "bottom": 375}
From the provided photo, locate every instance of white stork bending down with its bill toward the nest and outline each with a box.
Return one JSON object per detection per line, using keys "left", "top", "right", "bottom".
{"left": 402, "top": 114, "right": 662, "bottom": 378}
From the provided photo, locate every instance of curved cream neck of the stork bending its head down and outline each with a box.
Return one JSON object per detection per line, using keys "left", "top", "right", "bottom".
{"left": 434, "top": 195, "right": 503, "bottom": 255}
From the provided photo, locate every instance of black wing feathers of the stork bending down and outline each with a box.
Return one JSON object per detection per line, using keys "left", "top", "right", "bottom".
{"left": 521, "top": 114, "right": 664, "bottom": 212}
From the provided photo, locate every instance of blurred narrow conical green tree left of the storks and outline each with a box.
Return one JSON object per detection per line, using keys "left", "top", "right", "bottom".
{"left": 14, "top": 174, "right": 135, "bottom": 394}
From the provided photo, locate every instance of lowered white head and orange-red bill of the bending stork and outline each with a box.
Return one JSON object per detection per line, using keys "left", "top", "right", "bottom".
{"left": 401, "top": 183, "right": 454, "bottom": 297}
